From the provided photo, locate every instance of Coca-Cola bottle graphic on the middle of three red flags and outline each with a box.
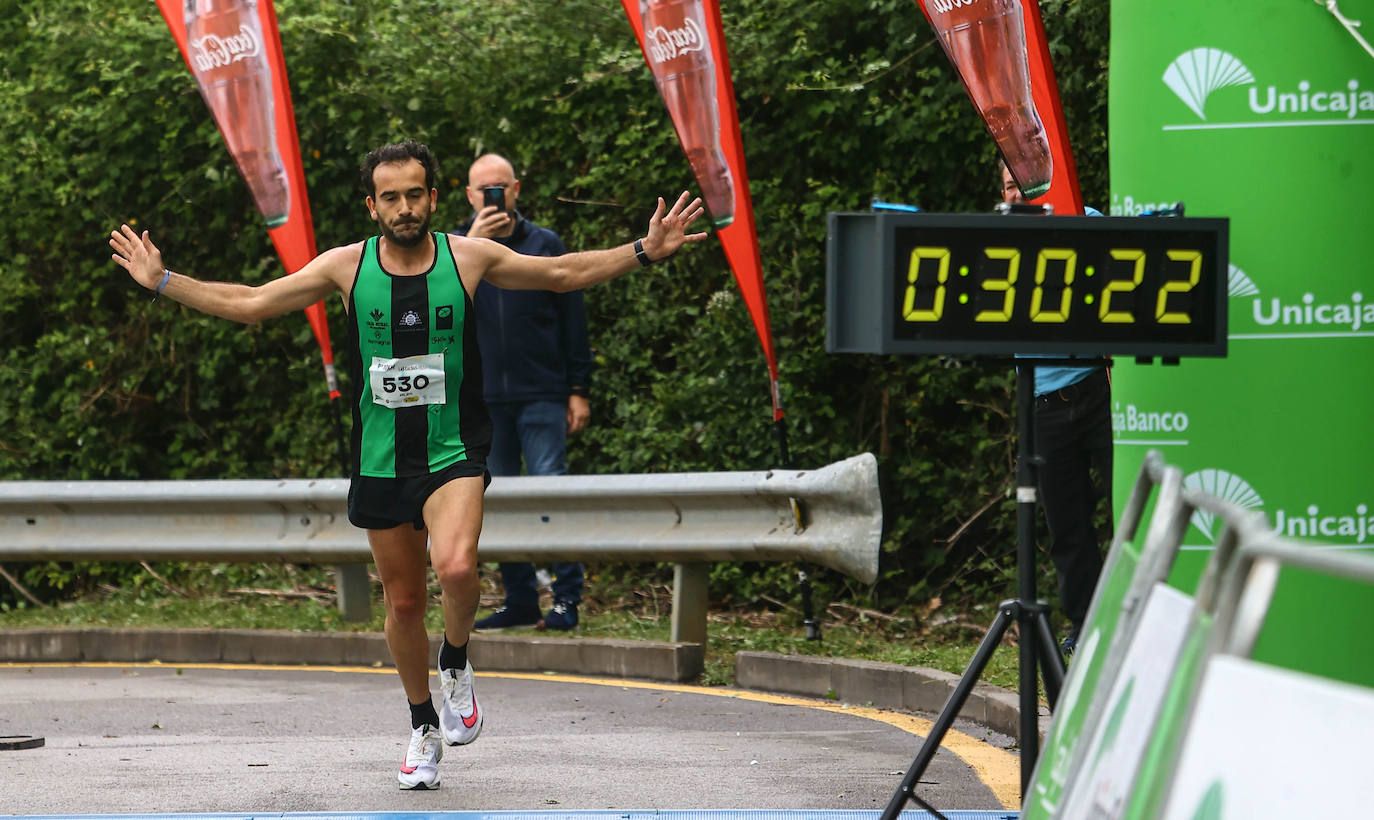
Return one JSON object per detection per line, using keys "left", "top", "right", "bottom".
{"left": 639, "top": 0, "right": 735, "bottom": 228}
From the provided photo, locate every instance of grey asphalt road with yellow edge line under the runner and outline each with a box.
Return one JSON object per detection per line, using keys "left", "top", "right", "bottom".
{"left": 0, "top": 663, "right": 1017, "bottom": 815}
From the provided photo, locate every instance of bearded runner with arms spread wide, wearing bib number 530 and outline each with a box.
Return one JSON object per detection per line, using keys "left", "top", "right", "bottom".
{"left": 110, "top": 140, "right": 706, "bottom": 788}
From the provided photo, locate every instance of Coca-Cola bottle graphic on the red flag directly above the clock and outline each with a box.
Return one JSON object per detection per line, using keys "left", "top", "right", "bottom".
{"left": 926, "top": 0, "right": 1054, "bottom": 199}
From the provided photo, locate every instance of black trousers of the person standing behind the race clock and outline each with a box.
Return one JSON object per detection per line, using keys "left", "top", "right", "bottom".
{"left": 1035, "top": 368, "right": 1114, "bottom": 633}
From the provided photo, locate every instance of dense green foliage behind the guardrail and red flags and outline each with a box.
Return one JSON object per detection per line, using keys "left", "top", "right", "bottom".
{"left": 0, "top": 0, "right": 1107, "bottom": 610}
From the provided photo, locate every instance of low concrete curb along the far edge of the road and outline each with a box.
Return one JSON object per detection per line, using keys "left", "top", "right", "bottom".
{"left": 0, "top": 628, "right": 1048, "bottom": 738}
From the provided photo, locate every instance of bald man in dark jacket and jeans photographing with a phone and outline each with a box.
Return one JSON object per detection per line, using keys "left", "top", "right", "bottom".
{"left": 455, "top": 154, "right": 592, "bottom": 632}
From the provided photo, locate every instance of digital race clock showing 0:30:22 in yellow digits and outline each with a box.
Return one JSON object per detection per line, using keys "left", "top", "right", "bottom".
{"left": 826, "top": 213, "right": 1228, "bottom": 357}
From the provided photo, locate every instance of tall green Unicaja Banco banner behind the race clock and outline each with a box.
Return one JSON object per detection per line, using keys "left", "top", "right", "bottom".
{"left": 1109, "top": 0, "right": 1374, "bottom": 565}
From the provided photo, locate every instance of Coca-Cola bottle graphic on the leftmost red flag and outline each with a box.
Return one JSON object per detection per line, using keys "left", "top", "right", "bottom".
{"left": 185, "top": 0, "right": 291, "bottom": 228}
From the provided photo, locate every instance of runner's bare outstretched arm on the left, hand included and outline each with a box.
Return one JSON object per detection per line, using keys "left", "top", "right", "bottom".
{"left": 110, "top": 225, "right": 348, "bottom": 324}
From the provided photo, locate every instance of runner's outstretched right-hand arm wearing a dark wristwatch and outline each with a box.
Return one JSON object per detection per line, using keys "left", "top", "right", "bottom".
{"left": 472, "top": 191, "right": 706, "bottom": 291}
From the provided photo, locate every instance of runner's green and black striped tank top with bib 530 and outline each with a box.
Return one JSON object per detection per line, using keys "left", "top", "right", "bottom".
{"left": 349, "top": 234, "right": 492, "bottom": 478}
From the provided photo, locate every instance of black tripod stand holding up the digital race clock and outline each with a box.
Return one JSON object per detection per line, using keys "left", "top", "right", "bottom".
{"left": 882, "top": 358, "right": 1081, "bottom": 820}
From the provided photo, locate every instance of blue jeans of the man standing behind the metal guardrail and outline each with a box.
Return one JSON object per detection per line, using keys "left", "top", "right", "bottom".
{"left": 486, "top": 401, "right": 583, "bottom": 608}
